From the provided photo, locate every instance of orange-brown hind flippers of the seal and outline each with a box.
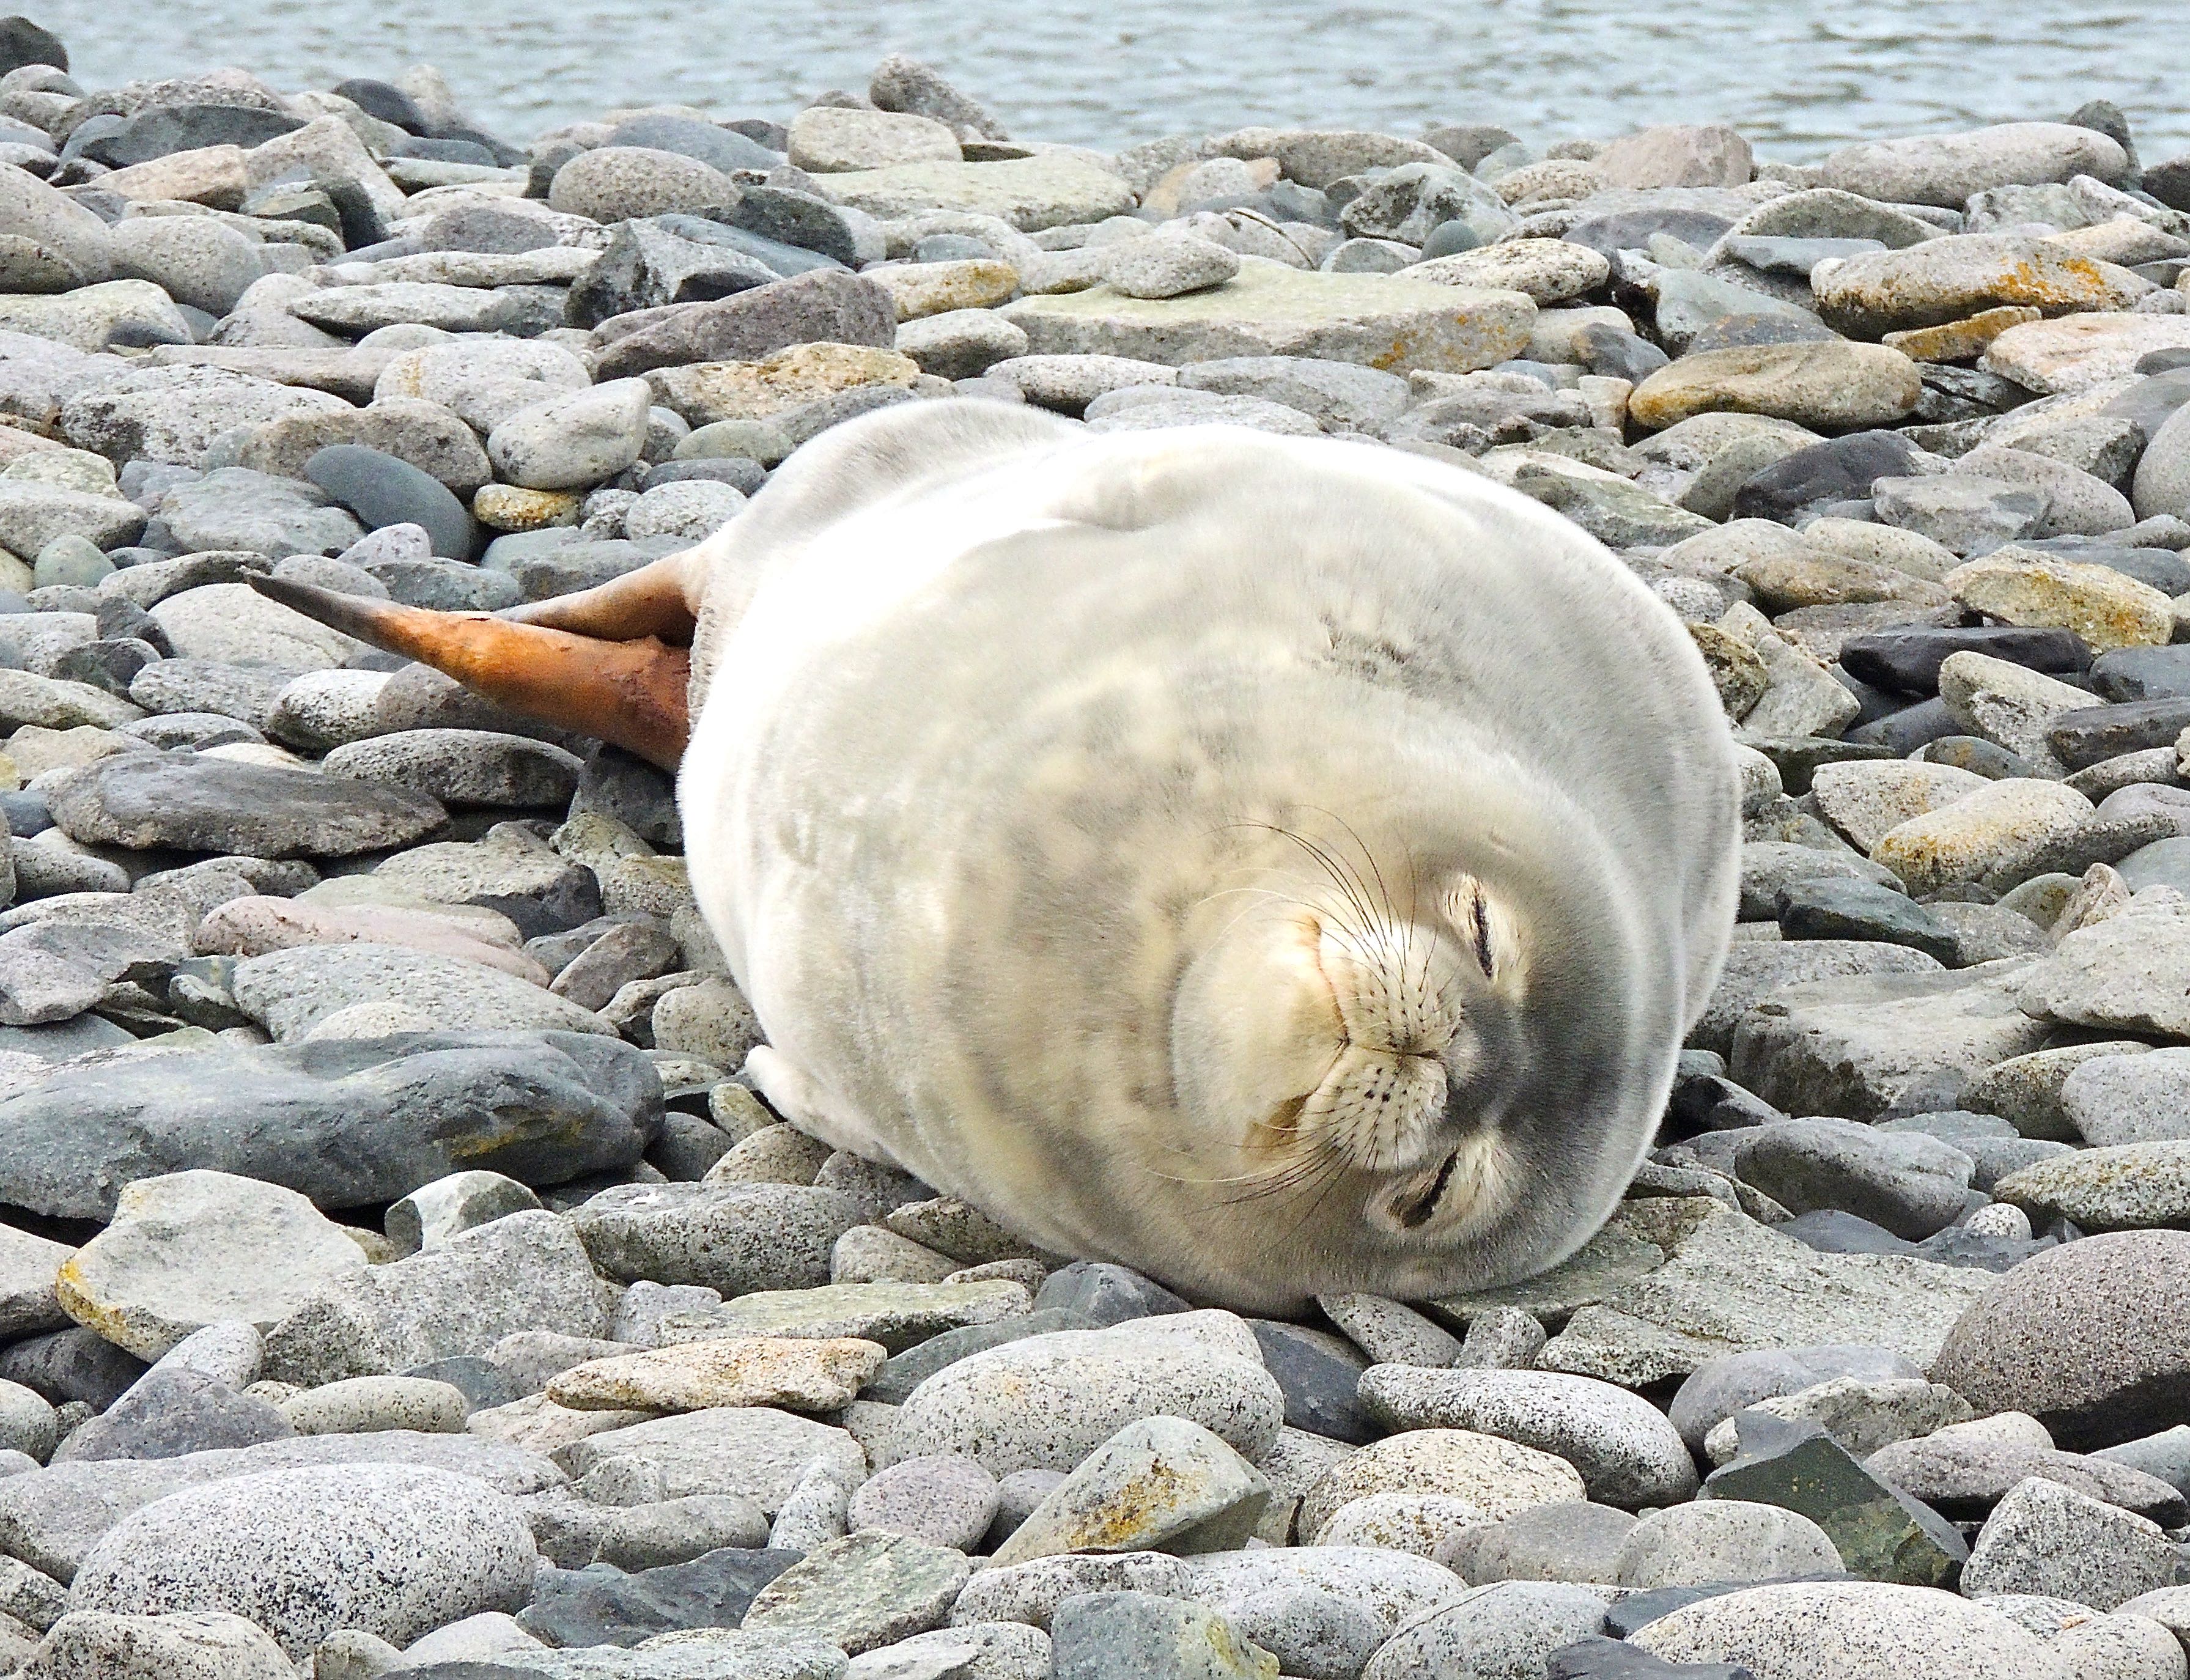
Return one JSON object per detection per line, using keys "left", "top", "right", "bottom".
{"left": 249, "top": 554, "right": 694, "bottom": 771}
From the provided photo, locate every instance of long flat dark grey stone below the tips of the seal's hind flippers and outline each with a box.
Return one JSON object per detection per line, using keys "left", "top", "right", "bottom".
{"left": 46, "top": 753, "right": 449, "bottom": 858}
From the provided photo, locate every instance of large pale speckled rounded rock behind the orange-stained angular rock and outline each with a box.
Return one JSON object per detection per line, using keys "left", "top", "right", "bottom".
{"left": 876, "top": 1312, "right": 1286, "bottom": 1476}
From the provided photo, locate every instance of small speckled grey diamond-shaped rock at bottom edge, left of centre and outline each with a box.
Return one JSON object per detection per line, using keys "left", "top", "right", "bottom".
{"left": 740, "top": 1531, "right": 970, "bottom": 1654}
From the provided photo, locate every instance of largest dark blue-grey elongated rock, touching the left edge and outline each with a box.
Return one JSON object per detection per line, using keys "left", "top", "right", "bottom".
{"left": 0, "top": 1031, "right": 662, "bottom": 1218}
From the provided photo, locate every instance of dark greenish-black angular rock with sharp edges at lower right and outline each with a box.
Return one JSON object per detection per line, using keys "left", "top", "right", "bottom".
{"left": 1704, "top": 1410, "right": 1969, "bottom": 1590}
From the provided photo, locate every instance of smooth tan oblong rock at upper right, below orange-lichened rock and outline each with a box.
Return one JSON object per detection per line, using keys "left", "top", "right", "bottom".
{"left": 1627, "top": 342, "right": 1923, "bottom": 429}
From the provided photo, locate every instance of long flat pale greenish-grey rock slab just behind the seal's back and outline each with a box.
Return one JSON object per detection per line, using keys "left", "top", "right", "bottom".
{"left": 1003, "top": 262, "right": 1533, "bottom": 372}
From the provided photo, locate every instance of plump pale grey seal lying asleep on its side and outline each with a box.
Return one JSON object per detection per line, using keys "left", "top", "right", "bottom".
{"left": 260, "top": 401, "right": 1739, "bottom": 1310}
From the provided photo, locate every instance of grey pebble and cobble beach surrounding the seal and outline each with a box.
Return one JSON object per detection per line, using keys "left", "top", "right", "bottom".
{"left": 0, "top": 18, "right": 2190, "bottom": 1680}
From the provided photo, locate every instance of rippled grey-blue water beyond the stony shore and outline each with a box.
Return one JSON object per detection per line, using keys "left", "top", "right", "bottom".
{"left": 31, "top": 0, "right": 2190, "bottom": 162}
